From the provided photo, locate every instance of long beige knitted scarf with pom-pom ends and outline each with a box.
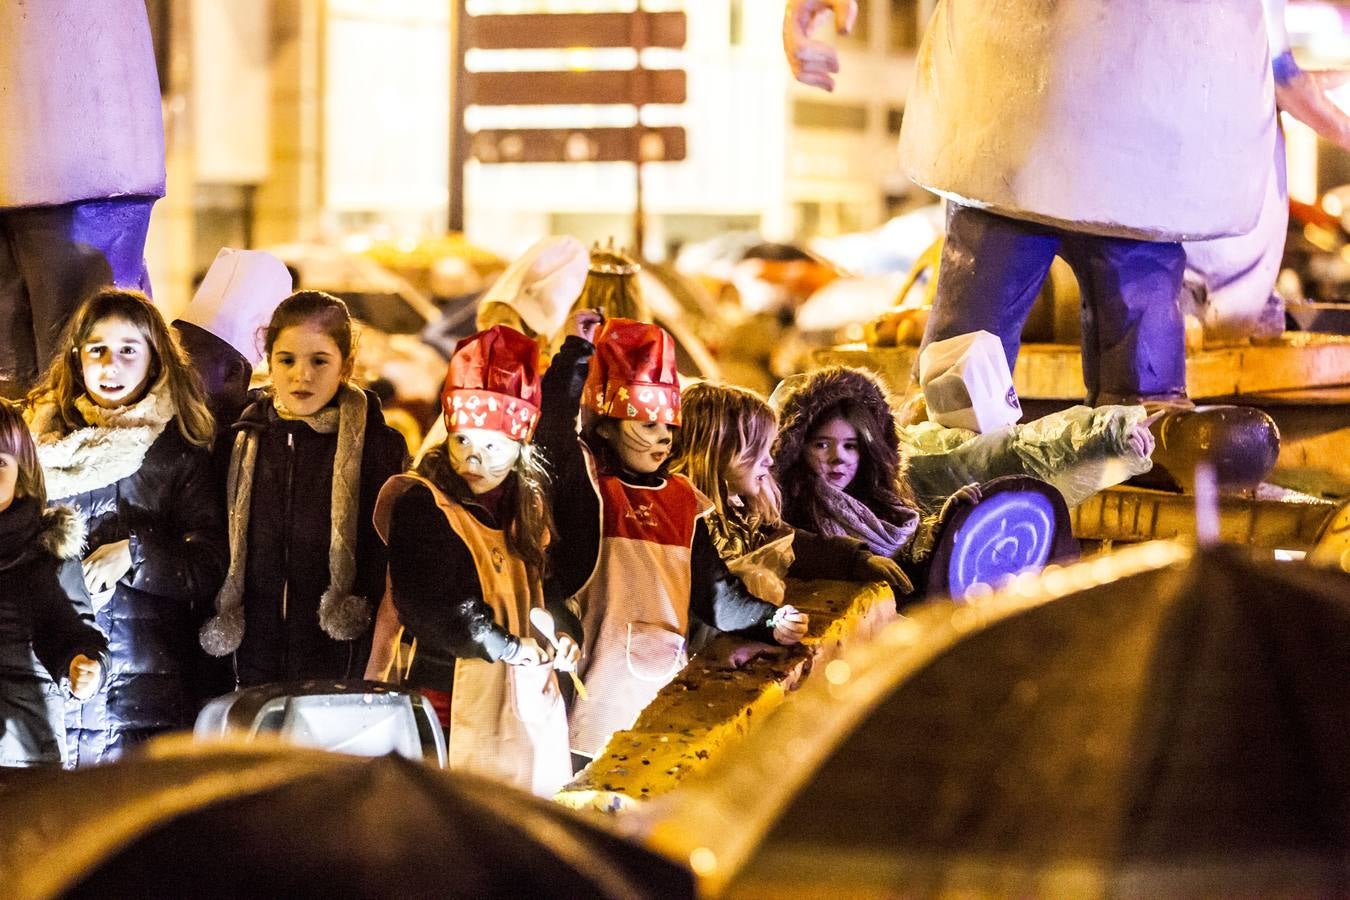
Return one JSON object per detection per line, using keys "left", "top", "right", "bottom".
{"left": 198, "top": 385, "right": 370, "bottom": 656}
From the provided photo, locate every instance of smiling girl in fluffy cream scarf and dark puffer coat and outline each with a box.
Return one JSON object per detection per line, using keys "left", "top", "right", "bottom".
{"left": 27, "top": 287, "right": 228, "bottom": 765}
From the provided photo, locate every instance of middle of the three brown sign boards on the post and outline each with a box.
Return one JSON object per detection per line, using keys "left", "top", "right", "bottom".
{"left": 468, "top": 69, "right": 684, "bottom": 107}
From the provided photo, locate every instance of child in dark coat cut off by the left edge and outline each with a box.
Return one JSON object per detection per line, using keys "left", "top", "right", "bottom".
{"left": 0, "top": 401, "right": 108, "bottom": 766}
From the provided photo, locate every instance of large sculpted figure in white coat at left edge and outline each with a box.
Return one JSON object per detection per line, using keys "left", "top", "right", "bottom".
{"left": 0, "top": 0, "right": 165, "bottom": 395}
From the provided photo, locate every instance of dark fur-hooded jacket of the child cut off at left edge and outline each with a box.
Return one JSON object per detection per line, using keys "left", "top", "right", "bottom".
{"left": 0, "top": 498, "right": 108, "bottom": 766}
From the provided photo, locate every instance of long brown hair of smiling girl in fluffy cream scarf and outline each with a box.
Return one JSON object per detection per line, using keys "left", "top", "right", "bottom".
{"left": 28, "top": 287, "right": 216, "bottom": 449}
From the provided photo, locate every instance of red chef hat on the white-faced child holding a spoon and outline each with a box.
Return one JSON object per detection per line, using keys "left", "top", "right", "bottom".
{"left": 440, "top": 325, "right": 539, "bottom": 441}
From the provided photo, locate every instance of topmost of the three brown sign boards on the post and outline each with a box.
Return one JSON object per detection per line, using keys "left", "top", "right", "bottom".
{"left": 467, "top": 11, "right": 686, "bottom": 50}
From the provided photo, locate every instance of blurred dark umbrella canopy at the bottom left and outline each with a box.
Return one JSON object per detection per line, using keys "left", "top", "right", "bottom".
{"left": 0, "top": 742, "right": 693, "bottom": 900}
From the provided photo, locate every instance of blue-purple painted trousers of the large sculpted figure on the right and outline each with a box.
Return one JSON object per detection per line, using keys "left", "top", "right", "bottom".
{"left": 923, "top": 202, "right": 1185, "bottom": 406}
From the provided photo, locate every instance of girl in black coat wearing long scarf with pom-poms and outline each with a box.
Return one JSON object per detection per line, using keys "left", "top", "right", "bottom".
{"left": 198, "top": 290, "right": 406, "bottom": 687}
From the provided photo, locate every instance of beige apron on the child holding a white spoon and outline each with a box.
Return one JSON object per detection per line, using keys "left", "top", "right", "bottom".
{"left": 375, "top": 475, "right": 572, "bottom": 797}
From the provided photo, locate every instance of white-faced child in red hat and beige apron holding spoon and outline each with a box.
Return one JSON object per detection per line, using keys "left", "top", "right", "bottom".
{"left": 375, "top": 325, "right": 581, "bottom": 796}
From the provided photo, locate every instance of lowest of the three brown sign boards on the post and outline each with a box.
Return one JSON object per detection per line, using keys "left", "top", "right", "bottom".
{"left": 473, "top": 128, "right": 684, "bottom": 163}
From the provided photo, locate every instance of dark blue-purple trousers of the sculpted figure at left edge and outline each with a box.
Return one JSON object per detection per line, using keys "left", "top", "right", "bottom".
{"left": 0, "top": 197, "right": 155, "bottom": 397}
